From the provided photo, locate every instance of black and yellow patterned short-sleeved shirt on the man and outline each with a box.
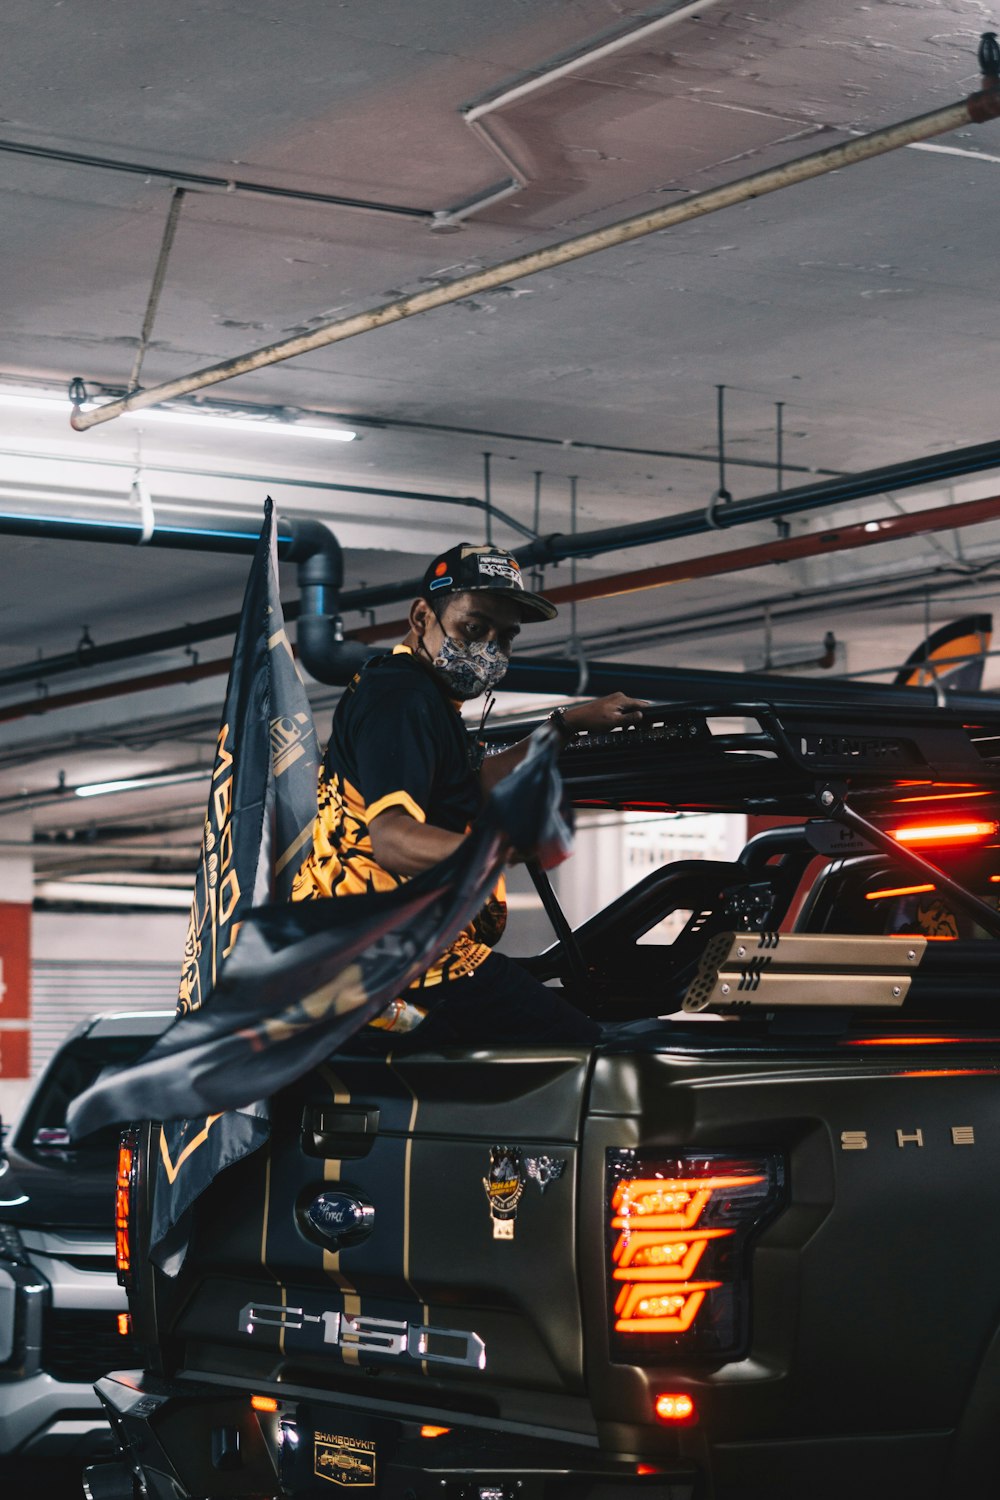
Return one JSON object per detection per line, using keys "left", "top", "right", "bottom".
{"left": 292, "top": 647, "right": 507, "bottom": 989}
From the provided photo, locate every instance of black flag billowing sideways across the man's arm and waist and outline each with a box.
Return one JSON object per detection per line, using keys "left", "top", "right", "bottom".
{"left": 69, "top": 726, "right": 570, "bottom": 1146}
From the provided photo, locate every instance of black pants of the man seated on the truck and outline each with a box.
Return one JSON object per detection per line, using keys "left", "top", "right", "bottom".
{"left": 395, "top": 953, "right": 601, "bottom": 1053}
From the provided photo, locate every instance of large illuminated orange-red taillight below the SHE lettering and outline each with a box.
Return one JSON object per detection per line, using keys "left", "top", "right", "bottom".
{"left": 607, "top": 1151, "right": 784, "bottom": 1365}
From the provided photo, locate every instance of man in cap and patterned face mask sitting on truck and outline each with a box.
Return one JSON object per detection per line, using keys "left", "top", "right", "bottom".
{"left": 292, "top": 543, "right": 642, "bottom": 1047}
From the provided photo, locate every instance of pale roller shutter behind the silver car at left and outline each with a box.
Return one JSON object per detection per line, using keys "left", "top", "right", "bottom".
{"left": 31, "top": 959, "right": 180, "bottom": 1079}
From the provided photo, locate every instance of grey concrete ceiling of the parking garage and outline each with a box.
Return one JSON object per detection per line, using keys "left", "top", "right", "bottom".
{"left": 0, "top": 0, "right": 1000, "bottom": 888}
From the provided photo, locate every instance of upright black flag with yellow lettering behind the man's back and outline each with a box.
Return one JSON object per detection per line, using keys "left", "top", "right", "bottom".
{"left": 129, "top": 498, "right": 318, "bottom": 1269}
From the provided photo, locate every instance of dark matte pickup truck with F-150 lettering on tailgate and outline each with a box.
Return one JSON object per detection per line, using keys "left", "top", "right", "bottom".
{"left": 87, "top": 702, "right": 1000, "bottom": 1500}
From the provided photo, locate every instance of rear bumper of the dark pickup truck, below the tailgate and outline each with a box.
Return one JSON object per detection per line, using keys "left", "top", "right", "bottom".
{"left": 96, "top": 1373, "right": 696, "bottom": 1500}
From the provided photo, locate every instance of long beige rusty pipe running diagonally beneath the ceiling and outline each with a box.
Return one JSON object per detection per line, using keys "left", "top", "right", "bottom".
{"left": 70, "top": 83, "right": 1000, "bottom": 432}
